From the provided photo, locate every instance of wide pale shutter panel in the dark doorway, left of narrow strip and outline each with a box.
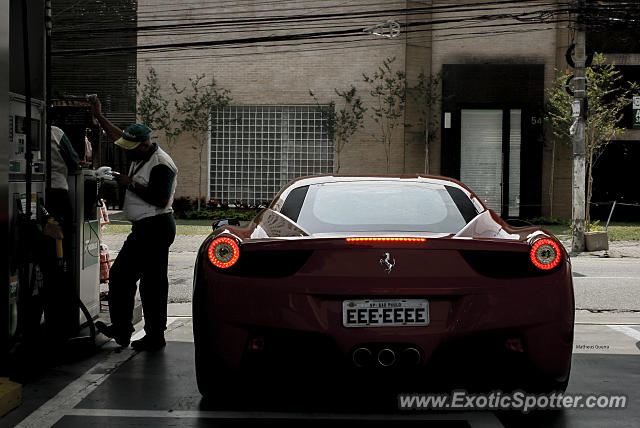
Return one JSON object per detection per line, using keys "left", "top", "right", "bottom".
{"left": 460, "top": 110, "right": 502, "bottom": 214}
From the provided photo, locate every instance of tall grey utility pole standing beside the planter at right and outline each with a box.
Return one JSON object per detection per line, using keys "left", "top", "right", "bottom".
{"left": 571, "top": 0, "right": 587, "bottom": 253}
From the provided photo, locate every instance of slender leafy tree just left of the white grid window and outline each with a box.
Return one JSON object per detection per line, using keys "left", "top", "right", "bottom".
{"left": 172, "top": 74, "right": 231, "bottom": 210}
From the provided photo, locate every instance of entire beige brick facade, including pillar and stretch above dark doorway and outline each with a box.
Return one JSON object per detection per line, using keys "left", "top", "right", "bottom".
{"left": 138, "top": 0, "right": 571, "bottom": 217}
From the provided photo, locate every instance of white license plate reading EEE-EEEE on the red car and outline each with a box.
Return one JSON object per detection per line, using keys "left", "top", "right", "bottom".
{"left": 342, "top": 299, "right": 429, "bottom": 327}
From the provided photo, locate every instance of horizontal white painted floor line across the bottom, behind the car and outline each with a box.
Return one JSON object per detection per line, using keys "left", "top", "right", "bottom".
{"left": 66, "top": 409, "right": 503, "bottom": 428}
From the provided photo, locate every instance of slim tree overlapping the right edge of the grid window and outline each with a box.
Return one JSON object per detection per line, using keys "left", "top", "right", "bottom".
{"left": 309, "top": 85, "right": 367, "bottom": 173}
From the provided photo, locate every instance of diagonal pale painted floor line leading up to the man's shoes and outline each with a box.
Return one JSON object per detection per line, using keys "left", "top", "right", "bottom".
{"left": 16, "top": 318, "right": 177, "bottom": 428}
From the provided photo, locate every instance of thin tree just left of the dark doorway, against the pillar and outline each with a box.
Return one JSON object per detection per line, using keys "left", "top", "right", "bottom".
{"left": 410, "top": 71, "right": 443, "bottom": 174}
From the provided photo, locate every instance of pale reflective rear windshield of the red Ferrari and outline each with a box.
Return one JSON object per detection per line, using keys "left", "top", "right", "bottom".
{"left": 285, "top": 181, "right": 467, "bottom": 233}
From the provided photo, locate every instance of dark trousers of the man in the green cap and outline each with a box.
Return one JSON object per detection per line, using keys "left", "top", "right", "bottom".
{"left": 109, "top": 213, "right": 176, "bottom": 337}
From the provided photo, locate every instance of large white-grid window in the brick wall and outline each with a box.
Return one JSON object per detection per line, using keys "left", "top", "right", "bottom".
{"left": 209, "top": 106, "right": 333, "bottom": 203}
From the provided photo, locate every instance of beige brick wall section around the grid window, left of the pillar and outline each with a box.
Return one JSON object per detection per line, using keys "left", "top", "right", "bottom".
{"left": 138, "top": 0, "right": 405, "bottom": 201}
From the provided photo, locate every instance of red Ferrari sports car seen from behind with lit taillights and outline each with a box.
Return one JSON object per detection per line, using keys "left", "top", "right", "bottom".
{"left": 193, "top": 175, "right": 574, "bottom": 396}
